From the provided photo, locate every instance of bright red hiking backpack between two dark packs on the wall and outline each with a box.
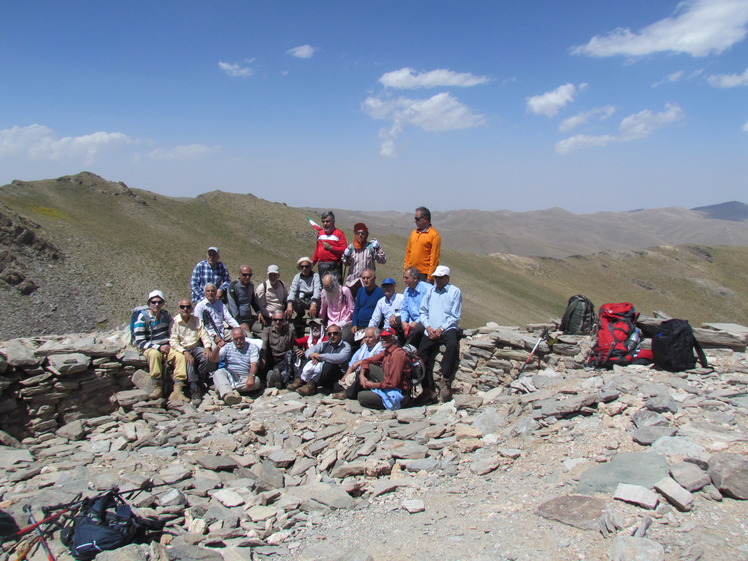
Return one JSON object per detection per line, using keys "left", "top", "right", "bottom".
{"left": 587, "top": 302, "right": 641, "bottom": 368}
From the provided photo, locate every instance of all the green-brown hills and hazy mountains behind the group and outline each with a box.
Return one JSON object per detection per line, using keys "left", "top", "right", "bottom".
{"left": 0, "top": 172, "right": 748, "bottom": 339}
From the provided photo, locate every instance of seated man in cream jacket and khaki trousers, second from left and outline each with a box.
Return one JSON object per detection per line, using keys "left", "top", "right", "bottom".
{"left": 169, "top": 298, "right": 213, "bottom": 406}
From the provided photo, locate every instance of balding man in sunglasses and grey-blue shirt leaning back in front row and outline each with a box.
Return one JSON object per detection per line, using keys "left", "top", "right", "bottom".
{"left": 288, "top": 323, "right": 351, "bottom": 395}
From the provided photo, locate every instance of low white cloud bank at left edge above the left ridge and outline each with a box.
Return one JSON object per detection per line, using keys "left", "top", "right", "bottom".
{"left": 0, "top": 124, "right": 136, "bottom": 164}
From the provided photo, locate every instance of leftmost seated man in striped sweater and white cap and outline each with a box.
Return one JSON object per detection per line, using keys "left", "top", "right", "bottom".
{"left": 133, "top": 290, "right": 173, "bottom": 399}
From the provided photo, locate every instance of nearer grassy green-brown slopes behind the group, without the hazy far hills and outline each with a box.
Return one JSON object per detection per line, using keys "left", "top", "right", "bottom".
{"left": 0, "top": 176, "right": 748, "bottom": 327}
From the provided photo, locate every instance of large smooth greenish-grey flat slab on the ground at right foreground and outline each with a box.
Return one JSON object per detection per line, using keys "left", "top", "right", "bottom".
{"left": 577, "top": 452, "right": 670, "bottom": 495}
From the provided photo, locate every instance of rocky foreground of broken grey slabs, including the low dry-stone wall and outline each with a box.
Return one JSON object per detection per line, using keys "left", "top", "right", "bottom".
{"left": 0, "top": 324, "right": 748, "bottom": 561}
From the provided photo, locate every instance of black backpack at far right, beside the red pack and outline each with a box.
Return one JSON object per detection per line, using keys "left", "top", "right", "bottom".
{"left": 652, "top": 319, "right": 709, "bottom": 372}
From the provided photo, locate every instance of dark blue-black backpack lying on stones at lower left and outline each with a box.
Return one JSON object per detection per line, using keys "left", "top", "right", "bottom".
{"left": 62, "top": 490, "right": 165, "bottom": 561}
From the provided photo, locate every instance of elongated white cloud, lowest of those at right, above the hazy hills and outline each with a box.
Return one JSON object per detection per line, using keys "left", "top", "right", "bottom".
{"left": 556, "top": 103, "right": 684, "bottom": 154}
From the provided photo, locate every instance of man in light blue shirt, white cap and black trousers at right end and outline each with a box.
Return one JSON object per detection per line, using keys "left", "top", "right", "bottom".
{"left": 418, "top": 265, "right": 462, "bottom": 403}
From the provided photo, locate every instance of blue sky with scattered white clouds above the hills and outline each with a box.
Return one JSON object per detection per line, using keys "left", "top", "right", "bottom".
{"left": 0, "top": 0, "right": 748, "bottom": 213}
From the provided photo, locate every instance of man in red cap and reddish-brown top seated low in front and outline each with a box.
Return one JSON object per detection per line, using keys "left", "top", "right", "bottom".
{"left": 358, "top": 329, "right": 411, "bottom": 409}
